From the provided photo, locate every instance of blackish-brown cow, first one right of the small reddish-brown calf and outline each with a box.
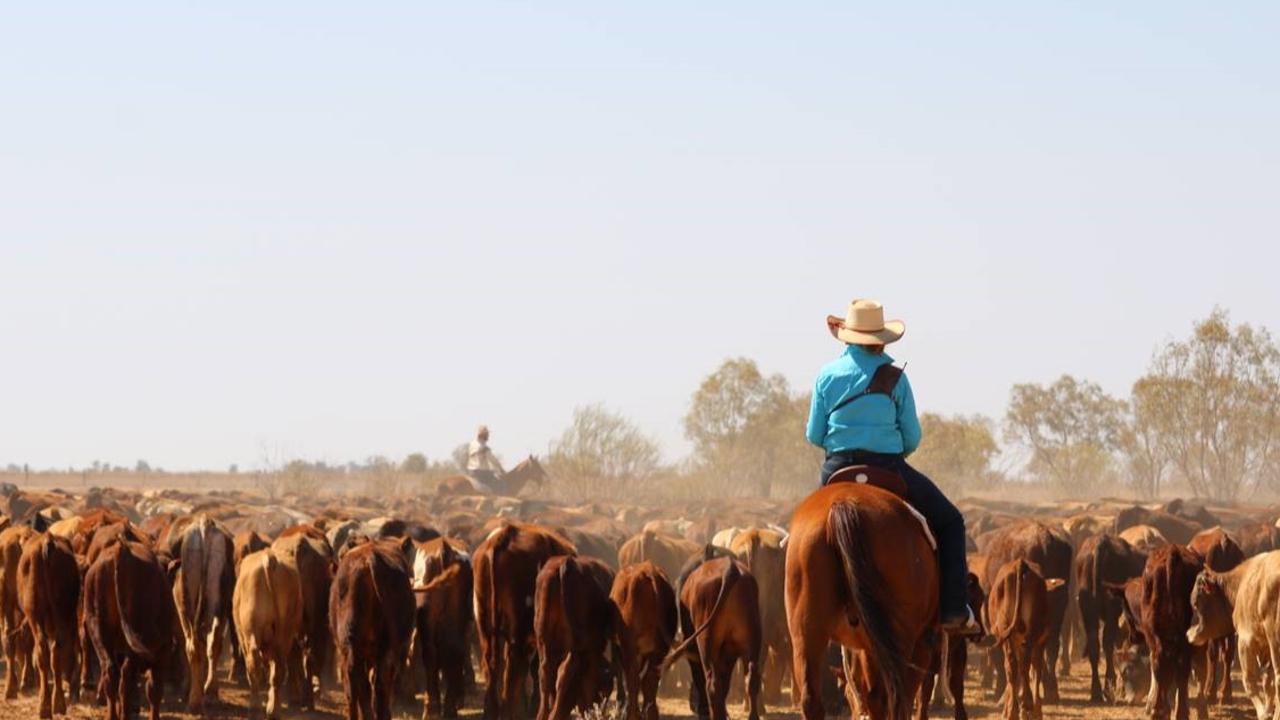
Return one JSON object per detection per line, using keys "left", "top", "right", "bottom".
{"left": 1075, "top": 533, "right": 1147, "bottom": 702}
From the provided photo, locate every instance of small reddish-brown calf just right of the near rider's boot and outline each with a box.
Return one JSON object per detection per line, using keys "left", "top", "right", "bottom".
{"left": 987, "top": 559, "right": 1062, "bottom": 720}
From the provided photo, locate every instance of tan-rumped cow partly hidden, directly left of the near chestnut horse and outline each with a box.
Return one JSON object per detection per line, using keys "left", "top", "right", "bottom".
{"left": 730, "top": 528, "right": 799, "bottom": 703}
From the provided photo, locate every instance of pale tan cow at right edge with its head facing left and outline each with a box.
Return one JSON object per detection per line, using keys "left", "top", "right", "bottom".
{"left": 1187, "top": 552, "right": 1280, "bottom": 720}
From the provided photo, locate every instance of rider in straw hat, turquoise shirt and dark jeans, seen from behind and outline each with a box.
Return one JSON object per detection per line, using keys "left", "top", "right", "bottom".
{"left": 805, "top": 300, "right": 979, "bottom": 634}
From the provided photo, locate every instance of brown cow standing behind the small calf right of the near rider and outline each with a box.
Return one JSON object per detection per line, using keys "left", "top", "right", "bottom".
{"left": 983, "top": 520, "right": 1071, "bottom": 702}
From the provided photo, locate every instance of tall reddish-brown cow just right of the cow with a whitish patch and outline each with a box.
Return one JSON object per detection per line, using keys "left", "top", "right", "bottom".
{"left": 472, "top": 523, "right": 577, "bottom": 720}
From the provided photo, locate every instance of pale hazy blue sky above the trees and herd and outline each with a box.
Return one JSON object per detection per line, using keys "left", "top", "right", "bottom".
{"left": 0, "top": 1, "right": 1280, "bottom": 469}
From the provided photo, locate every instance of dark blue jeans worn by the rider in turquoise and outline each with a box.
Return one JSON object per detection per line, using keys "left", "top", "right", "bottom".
{"left": 822, "top": 452, "right": 962, "bottom": 618}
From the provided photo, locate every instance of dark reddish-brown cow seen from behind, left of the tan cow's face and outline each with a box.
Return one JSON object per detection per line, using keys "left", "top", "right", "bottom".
{"left": 1138, "top": 544, "right": 1203, "bottom": 720}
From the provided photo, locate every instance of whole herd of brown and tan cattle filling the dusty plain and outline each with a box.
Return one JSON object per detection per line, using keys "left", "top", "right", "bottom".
{"left": 0, "top": 486, "right": 1280, "bottom": 720}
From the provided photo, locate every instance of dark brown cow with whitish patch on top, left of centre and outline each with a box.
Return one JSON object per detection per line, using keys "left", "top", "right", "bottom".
{"left": 413, "top": 538, "right": 475, "bottom": 719}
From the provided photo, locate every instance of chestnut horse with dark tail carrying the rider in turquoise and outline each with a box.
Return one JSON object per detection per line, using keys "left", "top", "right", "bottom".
{"left": 786, "top": 469, "right": 940, "bottom": 720}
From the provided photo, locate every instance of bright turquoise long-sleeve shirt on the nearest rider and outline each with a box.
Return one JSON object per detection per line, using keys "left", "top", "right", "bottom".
{"left": 805, "top": 345, "right": 920, "bottom": 455}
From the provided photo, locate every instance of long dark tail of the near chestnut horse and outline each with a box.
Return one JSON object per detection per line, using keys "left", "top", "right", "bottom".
{"left": 827, "top": 502, "right": 911, "bottom": 720}
